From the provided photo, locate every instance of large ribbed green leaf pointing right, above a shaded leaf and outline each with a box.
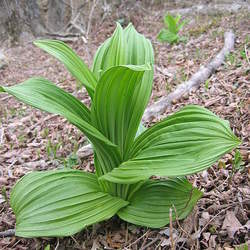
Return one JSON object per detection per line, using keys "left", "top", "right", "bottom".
{"left": 102, "top": 105, "right": 240, "bottom": 184}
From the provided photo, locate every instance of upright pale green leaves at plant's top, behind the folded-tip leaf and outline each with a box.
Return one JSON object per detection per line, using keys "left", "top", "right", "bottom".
{"left": 93, "top": 23, "right": 154, "bottom": 147}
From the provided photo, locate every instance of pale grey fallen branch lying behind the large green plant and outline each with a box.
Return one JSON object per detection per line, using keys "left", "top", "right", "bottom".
{"left": 77, "top": 31, "right": 235, "bottom": 158}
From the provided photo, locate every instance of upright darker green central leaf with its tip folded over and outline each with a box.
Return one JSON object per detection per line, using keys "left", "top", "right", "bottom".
{"left": 91, "top": 66, "right": 151, "bottom": 157}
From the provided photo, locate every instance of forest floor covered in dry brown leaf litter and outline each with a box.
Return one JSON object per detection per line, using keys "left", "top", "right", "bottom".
{"left": 0, "top": 1, "right": 250, "bottom": 250}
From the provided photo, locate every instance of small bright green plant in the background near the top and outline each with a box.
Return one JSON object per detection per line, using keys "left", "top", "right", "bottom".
{"left": 157, "top": 14, "right": 186, "bottom": 44}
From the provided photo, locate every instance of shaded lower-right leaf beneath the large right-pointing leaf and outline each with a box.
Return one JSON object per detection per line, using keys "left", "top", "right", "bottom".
{"left": 117, "top": 178, "right": 202, "bottom": 228}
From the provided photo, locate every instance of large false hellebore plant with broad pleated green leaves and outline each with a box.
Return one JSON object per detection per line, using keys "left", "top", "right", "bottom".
{"left": 0, "top": 24, "right": 240, "bottom": 237}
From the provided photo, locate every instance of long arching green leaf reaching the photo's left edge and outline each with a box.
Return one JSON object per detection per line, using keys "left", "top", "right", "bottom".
{"left": 0, "top": 78, "right": 121, "bottom": 180}
